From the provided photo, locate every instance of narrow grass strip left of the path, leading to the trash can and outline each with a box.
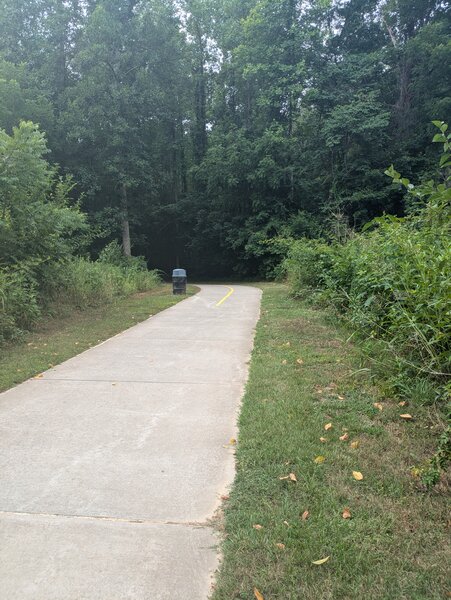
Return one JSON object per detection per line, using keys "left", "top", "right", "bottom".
{"left": 0, "top": 285, "right": 197, "bottom": 391}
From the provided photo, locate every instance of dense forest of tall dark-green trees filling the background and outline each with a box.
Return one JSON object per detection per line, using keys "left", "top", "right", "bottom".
{"left": 0, "top": 0, "right": 451, "bottom": 277}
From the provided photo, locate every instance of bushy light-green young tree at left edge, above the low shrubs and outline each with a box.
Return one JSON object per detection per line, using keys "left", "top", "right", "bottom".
{"left": 0, "top": 121, "right": 88, "bottom": 267}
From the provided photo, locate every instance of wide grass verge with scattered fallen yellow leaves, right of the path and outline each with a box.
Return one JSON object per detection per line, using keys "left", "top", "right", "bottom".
{"left": 213, "top": 284, "right": 450, "bottom": 600}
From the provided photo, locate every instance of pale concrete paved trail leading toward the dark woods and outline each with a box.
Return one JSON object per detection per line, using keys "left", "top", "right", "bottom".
{"left": 0, "top": 285, "right": 260, "bottom": 600}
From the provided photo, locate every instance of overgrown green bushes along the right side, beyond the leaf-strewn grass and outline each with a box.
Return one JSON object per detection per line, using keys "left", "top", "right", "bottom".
{"left": 283, "top": 126, "right": 451, "bottom": 487}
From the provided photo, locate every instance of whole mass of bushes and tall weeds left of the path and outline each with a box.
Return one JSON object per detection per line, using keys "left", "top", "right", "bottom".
{"left": 0, "top": 121, "right": 159, "bottom": 343}
